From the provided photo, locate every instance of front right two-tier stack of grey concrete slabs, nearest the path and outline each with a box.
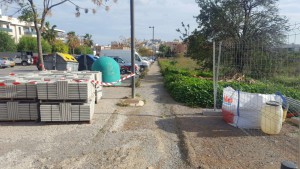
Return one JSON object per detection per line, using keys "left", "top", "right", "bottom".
{"left": 37, "top": 80, "right": 95, "bottom": 121}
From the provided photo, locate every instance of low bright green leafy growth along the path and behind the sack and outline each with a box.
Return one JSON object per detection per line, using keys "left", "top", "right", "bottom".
{"left": 159, "top": 59, "right": 300, "bottom": 108}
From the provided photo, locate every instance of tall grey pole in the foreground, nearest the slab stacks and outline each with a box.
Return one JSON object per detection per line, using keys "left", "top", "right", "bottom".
{"left": 130, "top": 0, "right": 135, "bottom": 98}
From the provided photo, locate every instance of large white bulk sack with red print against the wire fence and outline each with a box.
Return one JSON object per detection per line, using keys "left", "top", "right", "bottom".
{"left": 222, "top": 87, "right": 282, "bottom": 129}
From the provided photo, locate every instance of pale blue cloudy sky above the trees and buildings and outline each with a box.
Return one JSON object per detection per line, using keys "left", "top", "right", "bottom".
{"left": 2, "top": 0, "right": 300, "bottom": 45}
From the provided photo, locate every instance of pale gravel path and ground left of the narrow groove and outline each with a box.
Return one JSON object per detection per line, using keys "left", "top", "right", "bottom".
{"left": 0, "top": 63, "right": 191, "bottom": 169}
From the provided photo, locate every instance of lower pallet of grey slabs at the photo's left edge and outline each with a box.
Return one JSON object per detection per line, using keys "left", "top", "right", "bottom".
{"left": 0, "top": 101, "right": 38, "bottom": 121}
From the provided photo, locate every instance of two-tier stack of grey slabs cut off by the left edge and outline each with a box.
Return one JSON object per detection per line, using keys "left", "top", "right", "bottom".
{"left": 0, "top": 76, "right": 38, "bottom": 121}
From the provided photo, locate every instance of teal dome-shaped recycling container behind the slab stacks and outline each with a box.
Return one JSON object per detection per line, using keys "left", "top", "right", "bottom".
{"left": 92, "top": 56, "right": 121, "bottom": 85}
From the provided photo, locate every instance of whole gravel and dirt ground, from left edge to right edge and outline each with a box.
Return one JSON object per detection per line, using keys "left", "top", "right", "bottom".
{"left": 0, "top": 63, "right": 299, "bottom": 169}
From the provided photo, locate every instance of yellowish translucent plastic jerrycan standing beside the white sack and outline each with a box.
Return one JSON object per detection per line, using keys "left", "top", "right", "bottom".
{"left": 260, "top": 101, "right": 283, "bottom": 134}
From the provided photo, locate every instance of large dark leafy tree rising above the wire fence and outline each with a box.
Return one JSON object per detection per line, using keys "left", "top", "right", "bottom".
{"left": 176, "top": 0, "right": 289, "bottom": 72}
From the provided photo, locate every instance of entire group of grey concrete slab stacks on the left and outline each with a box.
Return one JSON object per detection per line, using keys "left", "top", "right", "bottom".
{"left": 0, "top": 71, "right": 102, "bottom": 122}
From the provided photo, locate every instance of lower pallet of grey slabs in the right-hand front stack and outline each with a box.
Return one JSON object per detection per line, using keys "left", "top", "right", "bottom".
{"left": 40, "top": 101, "right": 95, "bottom": 122}
